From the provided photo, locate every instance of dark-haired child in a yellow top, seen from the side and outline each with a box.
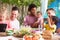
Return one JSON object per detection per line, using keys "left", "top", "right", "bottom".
{"left": 45, "top": 16, "right": 57, "bottom": 33}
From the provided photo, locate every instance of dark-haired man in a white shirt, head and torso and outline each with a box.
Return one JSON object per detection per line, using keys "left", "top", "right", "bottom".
{"left": 10, "top": 7, "right": 20, "bottom": 30}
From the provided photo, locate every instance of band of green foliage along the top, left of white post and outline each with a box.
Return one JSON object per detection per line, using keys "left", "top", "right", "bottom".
{"left": 1, "top": 0, "right": 40, "bottom": 6}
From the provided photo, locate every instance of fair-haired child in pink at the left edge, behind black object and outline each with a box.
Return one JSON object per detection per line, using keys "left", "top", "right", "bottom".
{"left": 0, "top": 8, "right": 11, "bottom": 30}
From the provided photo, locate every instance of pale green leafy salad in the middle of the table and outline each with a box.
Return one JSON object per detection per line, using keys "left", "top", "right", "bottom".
{"left": 15, "top": 27, "right": 31, "bottom": 37}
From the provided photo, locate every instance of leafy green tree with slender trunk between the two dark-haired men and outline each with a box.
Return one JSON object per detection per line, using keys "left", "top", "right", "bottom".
{"left": 0, "top": 0, "right": 55, "bottom": 23}
